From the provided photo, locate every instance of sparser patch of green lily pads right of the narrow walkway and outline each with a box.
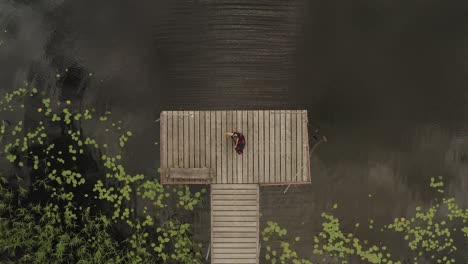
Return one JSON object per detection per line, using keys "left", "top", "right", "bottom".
{"left": 261, "top": 177, "right": 468, "bottom": 264}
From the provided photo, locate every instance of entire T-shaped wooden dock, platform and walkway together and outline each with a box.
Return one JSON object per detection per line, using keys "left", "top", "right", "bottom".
{"left": 160, "top": 110, "right": 310, "bottom": 263}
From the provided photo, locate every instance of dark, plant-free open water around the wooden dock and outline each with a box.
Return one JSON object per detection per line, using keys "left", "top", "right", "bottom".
{"left": 0, "top": 0, "right": 468, "bottom": 256}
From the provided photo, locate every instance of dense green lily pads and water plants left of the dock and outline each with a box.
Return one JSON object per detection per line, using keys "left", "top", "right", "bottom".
{"left": 0, "top": 85, "right": 206, "bottom": 263}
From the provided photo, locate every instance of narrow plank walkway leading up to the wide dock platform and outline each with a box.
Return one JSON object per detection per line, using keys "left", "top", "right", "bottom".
{"left": 211, "top": 184, "right": 259, "bottom": 264}
